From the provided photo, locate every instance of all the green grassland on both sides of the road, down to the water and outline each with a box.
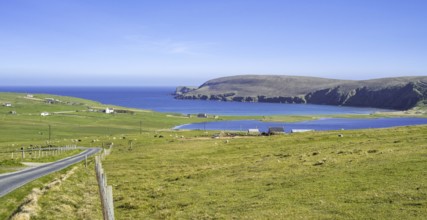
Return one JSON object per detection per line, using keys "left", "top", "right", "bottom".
{"left": 0, "top": 93, "right": 427, "bottom": 219}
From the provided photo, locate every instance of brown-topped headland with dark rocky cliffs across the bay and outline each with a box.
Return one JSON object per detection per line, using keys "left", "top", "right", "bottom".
{"left": 176, "top": 75, "right": 427, "bottom": 110}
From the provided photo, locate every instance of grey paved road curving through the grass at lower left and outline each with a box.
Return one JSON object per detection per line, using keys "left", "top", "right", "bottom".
{"left": 0, "top": 148, "right": 101, "bottom": 197}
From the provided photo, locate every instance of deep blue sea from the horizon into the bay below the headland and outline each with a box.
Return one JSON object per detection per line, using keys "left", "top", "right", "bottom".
{"left": 0, "top": 87, "right": 388, "bottom": 115}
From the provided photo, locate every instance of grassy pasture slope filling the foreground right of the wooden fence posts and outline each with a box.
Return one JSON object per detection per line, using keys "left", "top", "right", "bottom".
{"left": 104, "top": 126, "right": 427, "bottom": 219}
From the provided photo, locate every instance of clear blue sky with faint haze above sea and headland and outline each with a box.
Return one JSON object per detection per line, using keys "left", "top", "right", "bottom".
{"left": 0, "top": 0, "right": 427, "bottom": 86}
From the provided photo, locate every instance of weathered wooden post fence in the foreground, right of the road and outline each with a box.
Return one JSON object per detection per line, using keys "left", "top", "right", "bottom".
{"left": 95, "top": 145, "right": 114, "bottom": 220}
